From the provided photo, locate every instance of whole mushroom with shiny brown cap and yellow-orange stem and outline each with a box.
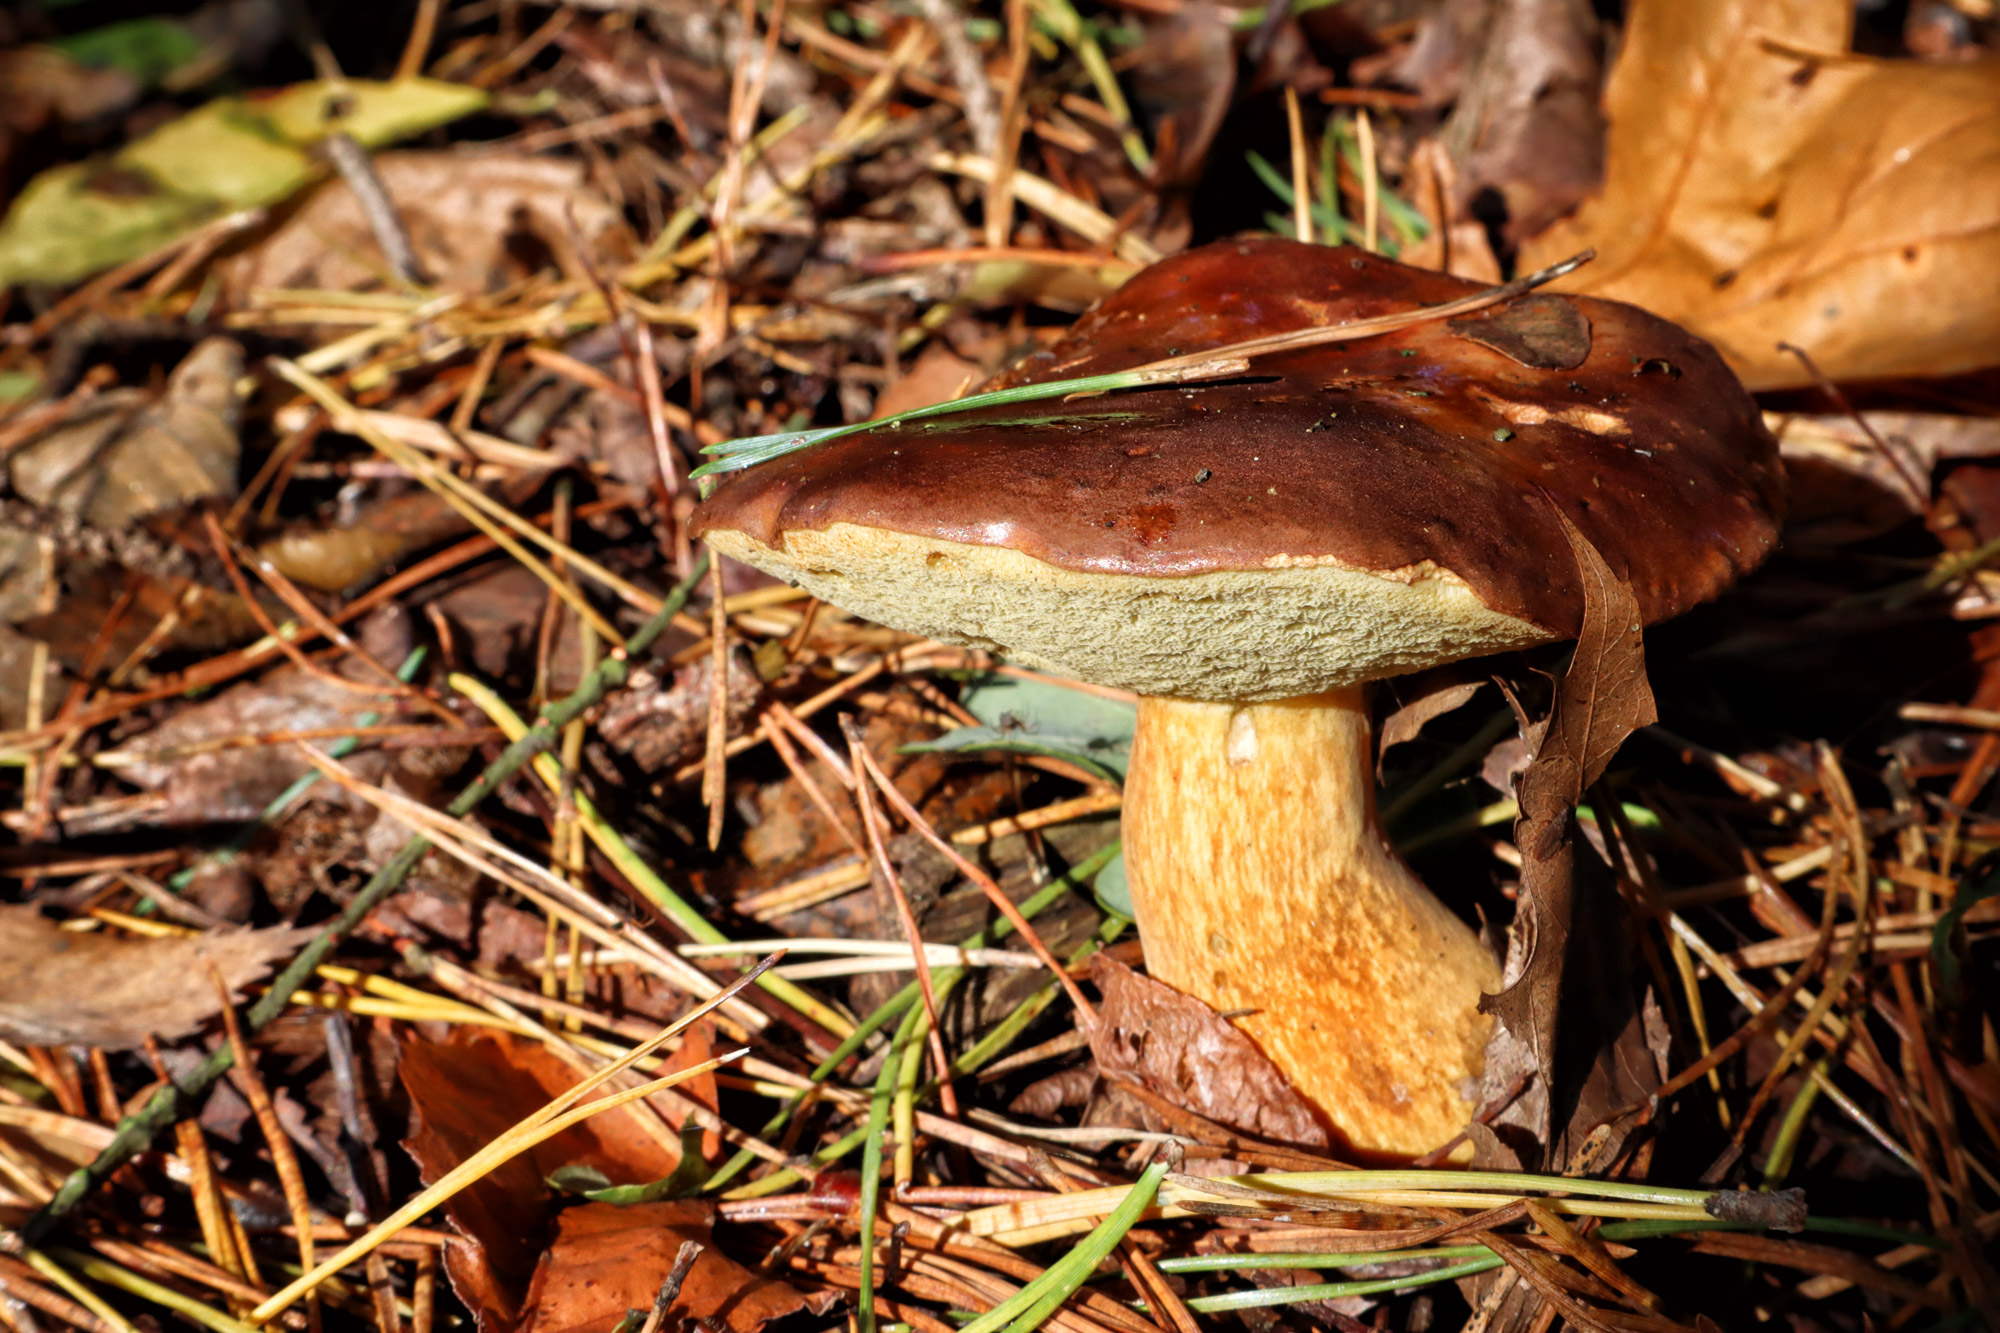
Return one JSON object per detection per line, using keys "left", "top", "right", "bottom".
{"left": 696, "top": 240, "right": 1782, "bottom": 1159}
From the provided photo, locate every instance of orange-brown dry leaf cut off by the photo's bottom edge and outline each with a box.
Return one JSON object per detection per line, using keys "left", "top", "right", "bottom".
{"left": 520, "top": 1199, "right": 838, "bottom": 1333}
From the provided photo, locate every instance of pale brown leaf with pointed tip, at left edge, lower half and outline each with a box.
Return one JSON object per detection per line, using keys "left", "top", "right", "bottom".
{"left": 0, "top": 907, "right": 312, "bottom": 1051}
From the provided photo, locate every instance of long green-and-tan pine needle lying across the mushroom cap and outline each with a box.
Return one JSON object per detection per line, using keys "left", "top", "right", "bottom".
{"left": 690, "top": 250, "right": 1596, "bottom": 478}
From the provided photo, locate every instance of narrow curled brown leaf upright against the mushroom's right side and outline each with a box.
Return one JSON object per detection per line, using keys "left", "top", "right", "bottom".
{"left": 1480, "top": 510, "right": 1656, "bottom": 1143}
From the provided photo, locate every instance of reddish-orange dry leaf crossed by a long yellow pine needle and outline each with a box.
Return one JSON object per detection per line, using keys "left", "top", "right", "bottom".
{"left": 398, "top": 1027, "right": 678, "bottom": 1333}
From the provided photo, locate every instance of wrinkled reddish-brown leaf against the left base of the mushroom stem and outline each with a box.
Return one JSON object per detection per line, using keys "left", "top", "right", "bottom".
{"left": 1090, "top": 953, "right": 1332, "bottom": 1147}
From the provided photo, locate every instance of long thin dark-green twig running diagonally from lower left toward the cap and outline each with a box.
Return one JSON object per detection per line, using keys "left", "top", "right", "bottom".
{"left": 22, "top": 552, "right": 708, "bottom": 1245}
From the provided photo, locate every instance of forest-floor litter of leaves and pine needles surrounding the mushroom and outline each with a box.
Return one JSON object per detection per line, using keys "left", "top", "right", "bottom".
{"left": 0, "top": 0, "right": 2000, "bottom": 1333}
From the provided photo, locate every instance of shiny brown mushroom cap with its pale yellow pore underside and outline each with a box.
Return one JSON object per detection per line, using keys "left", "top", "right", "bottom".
{"left": 696, "top": 240, "right": 1782, "bottom": 699}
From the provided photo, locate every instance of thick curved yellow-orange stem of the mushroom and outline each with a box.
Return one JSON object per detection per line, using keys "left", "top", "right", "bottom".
{"left": 1124, "top": 687, "right": 1500, "bottom": 1157}
